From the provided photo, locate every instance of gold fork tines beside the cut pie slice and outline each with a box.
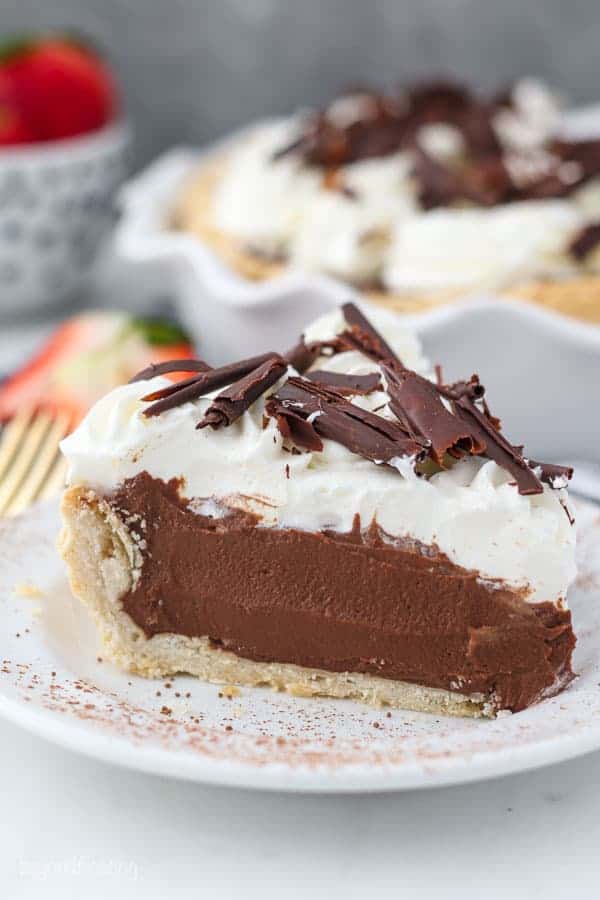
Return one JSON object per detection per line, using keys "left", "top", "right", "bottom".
{"left": 0, "top": 407, "right": 71, "bottom": 516}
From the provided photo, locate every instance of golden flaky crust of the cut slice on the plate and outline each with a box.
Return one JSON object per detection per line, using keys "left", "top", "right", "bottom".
{"left": 59, "top": 486, "right": 493, "bottom": 717}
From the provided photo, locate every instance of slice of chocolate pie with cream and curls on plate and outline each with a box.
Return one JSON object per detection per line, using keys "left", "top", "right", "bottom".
{"left": 61, "top": 304, "right": 575, "bottom": 715}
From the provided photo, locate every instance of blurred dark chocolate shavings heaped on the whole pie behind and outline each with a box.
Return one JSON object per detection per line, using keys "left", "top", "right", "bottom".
{"left": 273, "top": 80, "right": 600, "bottom": 209}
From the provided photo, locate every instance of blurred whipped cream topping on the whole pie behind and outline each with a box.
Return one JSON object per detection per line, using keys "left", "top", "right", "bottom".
{"left": 212, "top": 78, "right": 600, "bottom": 294}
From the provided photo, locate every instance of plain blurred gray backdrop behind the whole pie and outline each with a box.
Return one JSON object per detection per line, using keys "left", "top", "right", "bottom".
{"left": 0, "top": 0, "right": 600, "bottom": 164}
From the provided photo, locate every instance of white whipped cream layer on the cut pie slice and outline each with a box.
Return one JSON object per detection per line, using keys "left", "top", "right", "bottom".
{"left": 61, "top": 312, "right": 575, "bottom": 601}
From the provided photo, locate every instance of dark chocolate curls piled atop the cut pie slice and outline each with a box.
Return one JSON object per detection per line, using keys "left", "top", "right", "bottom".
{"left": 136, "top": 303, "right": 572, "bottom": 506}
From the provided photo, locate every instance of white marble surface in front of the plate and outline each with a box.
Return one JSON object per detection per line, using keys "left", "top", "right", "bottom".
{"left": 0, "top": 722, "right": 600, "bottom": 900}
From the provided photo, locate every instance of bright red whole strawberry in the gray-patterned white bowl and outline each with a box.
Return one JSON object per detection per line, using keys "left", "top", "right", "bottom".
{"left": 0, "top": 35, "right": 118, "bottom": 141}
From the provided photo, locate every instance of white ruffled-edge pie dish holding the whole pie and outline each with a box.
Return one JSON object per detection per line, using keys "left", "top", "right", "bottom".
{"left": 116, "top": 132, "right": 600, "bottom": 462}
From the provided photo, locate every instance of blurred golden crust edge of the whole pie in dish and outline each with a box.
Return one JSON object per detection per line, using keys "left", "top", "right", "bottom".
{"left": 170, "top": 156, "right": 600, "bottom": 323}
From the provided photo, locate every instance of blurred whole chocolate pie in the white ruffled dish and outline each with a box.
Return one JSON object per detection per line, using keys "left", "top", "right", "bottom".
{"left": 171, "top": 79, "right": 600, "bottom": 321}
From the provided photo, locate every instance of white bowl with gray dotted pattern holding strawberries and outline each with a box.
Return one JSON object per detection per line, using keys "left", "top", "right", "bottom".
{"left": 0, "top": 122, "right": 129, "bottom": 320}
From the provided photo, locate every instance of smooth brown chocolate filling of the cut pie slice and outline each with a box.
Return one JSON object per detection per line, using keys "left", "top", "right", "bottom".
{"left": 108, "top": 472, "right": 575, "bottom": 711}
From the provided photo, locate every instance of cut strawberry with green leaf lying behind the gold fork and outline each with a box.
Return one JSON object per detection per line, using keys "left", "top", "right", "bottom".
{"left": 0, "top": 312, "right": 193, "bottom": 427}
